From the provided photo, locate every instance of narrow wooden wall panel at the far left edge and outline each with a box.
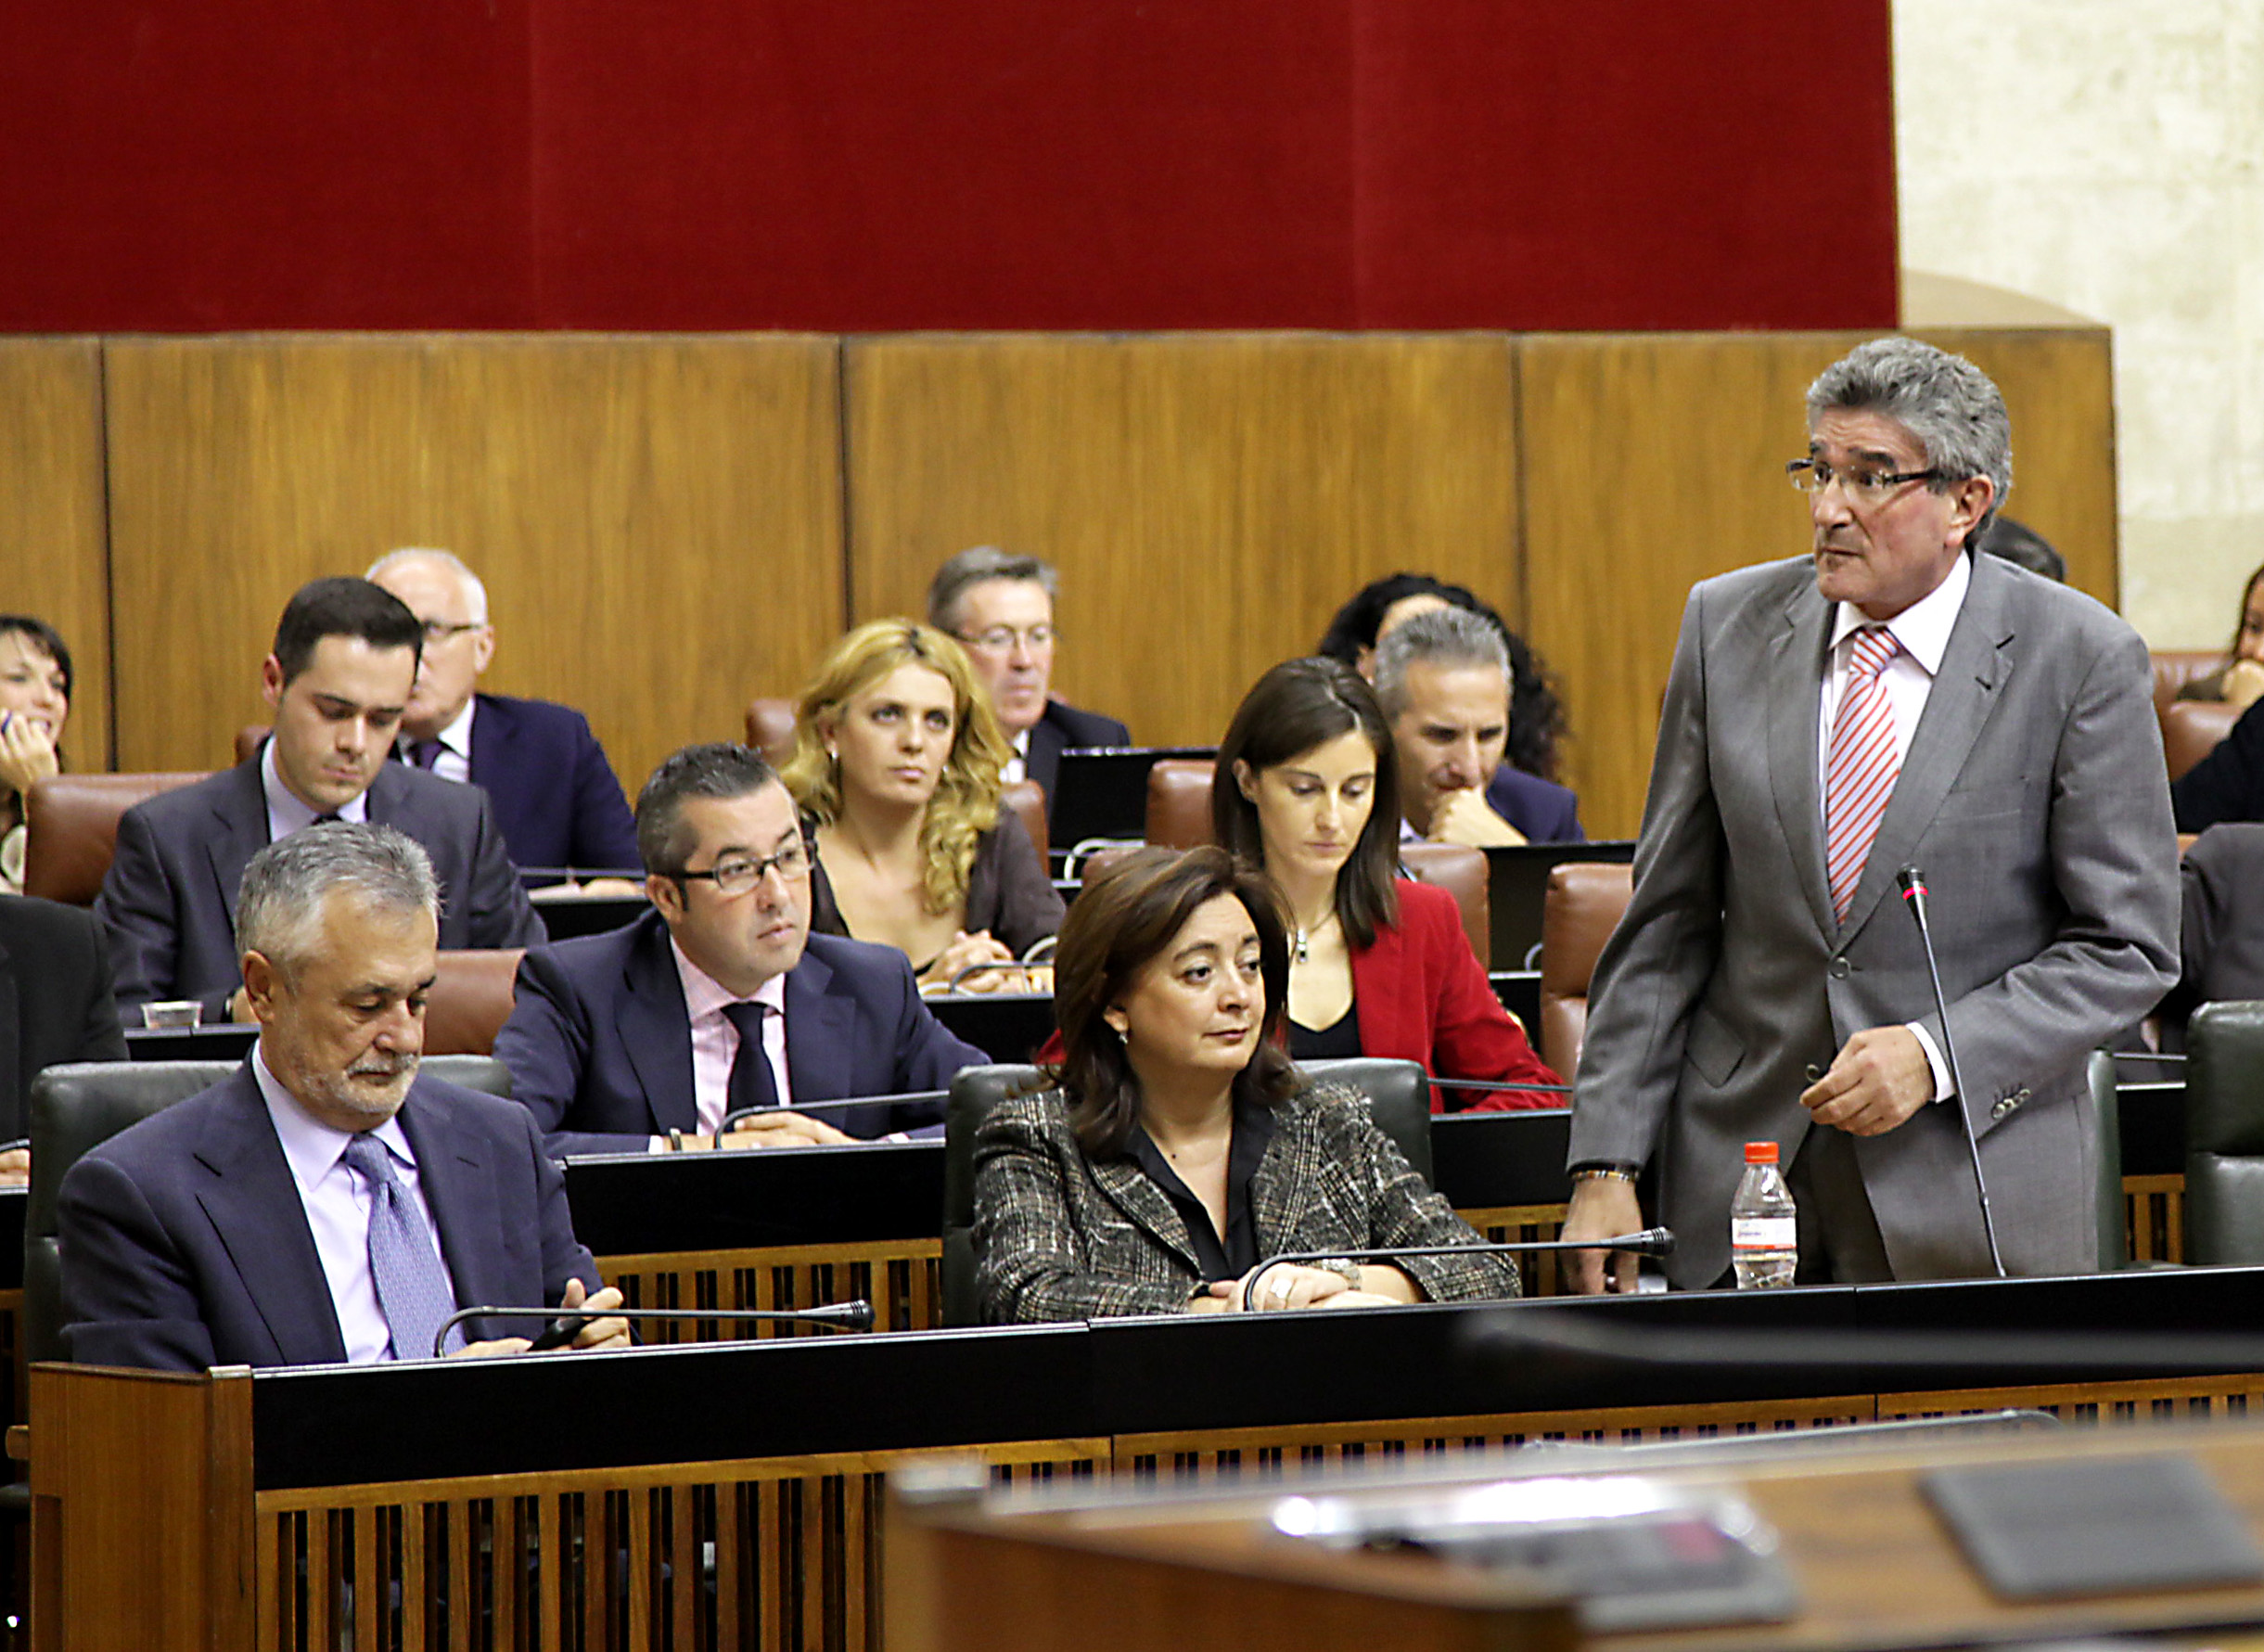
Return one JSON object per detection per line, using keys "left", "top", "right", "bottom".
{"left": 0, "top": 338, "right": 111, "bottom": 770}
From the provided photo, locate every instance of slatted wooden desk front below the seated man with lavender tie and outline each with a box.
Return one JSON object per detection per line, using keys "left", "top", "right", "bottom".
{"left": 253, "top": 1440, "right": 1109, "bottom": 1652}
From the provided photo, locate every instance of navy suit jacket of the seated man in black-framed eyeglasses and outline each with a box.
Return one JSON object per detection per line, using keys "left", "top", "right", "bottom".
{"left": 496, "top": 912, "right": 990, "bottom": 1157}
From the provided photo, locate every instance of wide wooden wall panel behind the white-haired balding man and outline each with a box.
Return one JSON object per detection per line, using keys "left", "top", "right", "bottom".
{"left": 107, "top": 335, "right": 842, "bottom": 792}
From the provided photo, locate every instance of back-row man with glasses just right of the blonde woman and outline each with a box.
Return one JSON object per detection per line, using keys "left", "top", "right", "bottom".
{"left": 928, "top": 545, "right": 1132, "bottom": 819}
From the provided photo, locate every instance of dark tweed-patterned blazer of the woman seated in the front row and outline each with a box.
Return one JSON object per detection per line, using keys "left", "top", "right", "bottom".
{"left": 974, "top": 1086, "right": 1516, "bottom": 1322}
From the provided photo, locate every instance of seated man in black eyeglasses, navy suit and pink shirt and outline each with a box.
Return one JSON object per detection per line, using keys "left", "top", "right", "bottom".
{"left": 496, "top": 745, "right": 990, "bottom": 1157}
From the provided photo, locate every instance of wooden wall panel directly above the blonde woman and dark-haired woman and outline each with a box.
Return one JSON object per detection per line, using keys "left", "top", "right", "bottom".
{"left": 844, "top": 333, "right": 1519, "bottom": 745}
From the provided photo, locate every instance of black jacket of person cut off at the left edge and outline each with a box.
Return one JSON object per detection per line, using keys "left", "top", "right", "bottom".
{"left": 0, "top": 894, "right": 127, "bottom": 1141}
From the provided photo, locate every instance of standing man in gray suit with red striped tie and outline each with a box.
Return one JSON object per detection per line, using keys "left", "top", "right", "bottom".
{"left": 1565, "top": 338, "right": 2178, "bottom": 1290}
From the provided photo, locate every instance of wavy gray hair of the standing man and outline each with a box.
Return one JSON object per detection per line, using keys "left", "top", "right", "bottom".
{"left": 1809, "top": 335, "right": 2013, "bottom": 547}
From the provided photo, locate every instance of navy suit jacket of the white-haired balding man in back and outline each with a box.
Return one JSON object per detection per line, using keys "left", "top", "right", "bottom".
{"left": 457, "top": 695, "right": 643, "bottom": 878}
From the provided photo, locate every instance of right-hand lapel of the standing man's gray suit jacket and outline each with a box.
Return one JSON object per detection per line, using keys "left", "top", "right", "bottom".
{"left": 1848, "top": 552, "right": 2013, "bottom": 935}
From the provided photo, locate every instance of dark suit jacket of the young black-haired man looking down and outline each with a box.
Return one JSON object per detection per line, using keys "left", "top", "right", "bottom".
{"left": 96, "top": 756, "right": 545, "bottom": 1023}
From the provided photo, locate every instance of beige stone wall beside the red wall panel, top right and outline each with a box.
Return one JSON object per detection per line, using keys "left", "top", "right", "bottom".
{"left": 1892, "top": 0, "right": 2264, "bottom": 649}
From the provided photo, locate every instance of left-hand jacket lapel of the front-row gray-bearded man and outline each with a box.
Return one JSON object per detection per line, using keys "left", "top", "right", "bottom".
{"left": 192, "top": 1061, "right": 346, "bottom": 1364}
